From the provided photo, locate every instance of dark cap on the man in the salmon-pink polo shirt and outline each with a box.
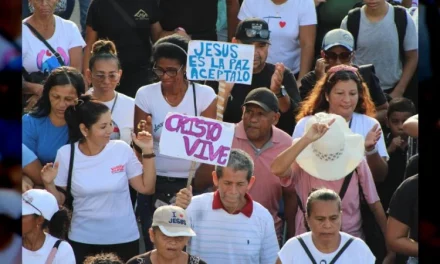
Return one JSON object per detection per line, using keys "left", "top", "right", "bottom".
{"left": 243, "top": 87, "right": 279, "bottom": 113}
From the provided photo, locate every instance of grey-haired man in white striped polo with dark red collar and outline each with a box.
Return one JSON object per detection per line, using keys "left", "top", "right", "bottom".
{"left": 176, "top": 149, "right": 279, "bottom": 264}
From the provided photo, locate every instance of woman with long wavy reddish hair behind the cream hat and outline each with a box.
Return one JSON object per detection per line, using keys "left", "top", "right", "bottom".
{"left": 292, "top": 65, "right": 389, "bottom": 182}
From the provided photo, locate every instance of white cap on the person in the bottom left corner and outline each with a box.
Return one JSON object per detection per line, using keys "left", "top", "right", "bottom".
{"left": 21, "top": 189, "right": 59, "bottom": 221}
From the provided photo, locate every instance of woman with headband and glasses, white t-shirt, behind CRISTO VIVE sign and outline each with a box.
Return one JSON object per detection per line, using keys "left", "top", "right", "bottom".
{"left": 134, "top": 35, "right": 217, "bottom": 210}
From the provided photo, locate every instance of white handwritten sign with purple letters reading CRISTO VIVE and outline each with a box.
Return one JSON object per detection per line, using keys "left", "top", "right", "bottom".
{"left": 159, "top": 113, "right": 234, "bottom": 166}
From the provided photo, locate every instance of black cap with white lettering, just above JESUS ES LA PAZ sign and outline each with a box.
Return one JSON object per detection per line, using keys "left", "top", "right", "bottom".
{"left": 235, "top": 18, "right": 270, "bottom": 44}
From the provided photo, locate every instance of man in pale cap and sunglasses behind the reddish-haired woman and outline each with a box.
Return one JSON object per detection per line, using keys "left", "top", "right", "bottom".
{"left": 299, "top": 28, "right": 388, "bottom": 122}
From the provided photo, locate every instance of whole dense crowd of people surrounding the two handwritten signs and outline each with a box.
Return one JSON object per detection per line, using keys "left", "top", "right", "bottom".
{"left": 0, "top": 0, "right": 426, "bottom": 264}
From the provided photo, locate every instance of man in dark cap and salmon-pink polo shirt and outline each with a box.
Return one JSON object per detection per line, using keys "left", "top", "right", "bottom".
{"left": 232, "top": 88, "right": 298, "bottom": 241}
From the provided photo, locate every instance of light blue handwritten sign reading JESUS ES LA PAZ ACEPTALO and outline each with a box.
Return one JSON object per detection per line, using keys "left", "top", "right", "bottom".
{"left": 186, "top": 40, "right": 255, "bottom": 84}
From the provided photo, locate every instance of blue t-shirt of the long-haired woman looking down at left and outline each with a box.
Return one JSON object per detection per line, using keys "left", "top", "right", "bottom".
{"left": 22, "top": 114, "right": 69, "bottom": 166}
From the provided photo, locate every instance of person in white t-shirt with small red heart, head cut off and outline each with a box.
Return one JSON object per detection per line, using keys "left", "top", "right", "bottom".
{"left": 238, "top": 0, "right": 317, "bottom": 83}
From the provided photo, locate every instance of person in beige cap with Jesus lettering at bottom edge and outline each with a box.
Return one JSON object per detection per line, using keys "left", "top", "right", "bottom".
{"left": 127, "top": 205, "right": 206, "bottom": 264}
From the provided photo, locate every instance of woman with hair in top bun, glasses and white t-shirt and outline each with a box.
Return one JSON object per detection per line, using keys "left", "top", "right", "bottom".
{"left": 86, "top": 40, "right": 134, "bottom": 144}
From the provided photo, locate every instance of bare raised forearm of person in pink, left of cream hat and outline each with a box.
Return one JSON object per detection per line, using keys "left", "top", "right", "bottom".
{"left": 270, "top": 137, "right": 311, "bottom": 177}
